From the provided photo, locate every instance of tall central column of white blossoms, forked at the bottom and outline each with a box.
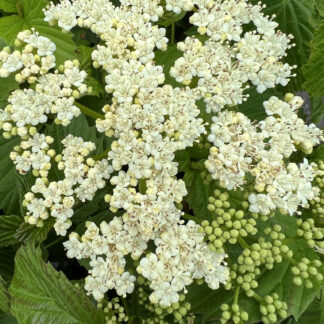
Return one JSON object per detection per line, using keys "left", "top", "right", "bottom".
{"left": 45, "top": 0, "right": 228, "bottom": 306}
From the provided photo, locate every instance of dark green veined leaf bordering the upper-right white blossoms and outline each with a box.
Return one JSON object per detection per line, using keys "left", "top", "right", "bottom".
{"left": 252, "top": 0, "right": 316, "bottom": 91}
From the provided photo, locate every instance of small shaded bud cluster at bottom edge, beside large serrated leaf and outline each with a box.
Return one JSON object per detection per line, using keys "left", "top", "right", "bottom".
{"left": 97, "top": 297, "right": 129, "bottom": 324}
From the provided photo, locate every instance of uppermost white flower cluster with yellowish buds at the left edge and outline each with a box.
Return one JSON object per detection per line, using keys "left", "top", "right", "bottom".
{"left": 0, "top": 30, "right": 56, "bottom": 79}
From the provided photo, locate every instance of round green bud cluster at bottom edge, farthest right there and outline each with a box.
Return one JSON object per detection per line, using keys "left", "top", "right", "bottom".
{"left": 260, "top": 293, "right": 288, "bottom": 324}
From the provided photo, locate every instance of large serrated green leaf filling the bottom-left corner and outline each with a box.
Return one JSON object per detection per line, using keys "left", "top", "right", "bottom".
{"left": 9, "top": 246, "right": 105, "bottom": 324}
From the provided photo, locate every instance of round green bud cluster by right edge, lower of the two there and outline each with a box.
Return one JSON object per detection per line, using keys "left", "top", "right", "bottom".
{"left": 291, "top": 258, "right": 323, "bottom": 289}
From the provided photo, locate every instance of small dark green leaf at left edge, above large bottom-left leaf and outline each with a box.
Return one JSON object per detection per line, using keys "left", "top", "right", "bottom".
{"left": 0, "top": 215, "right": 24, "bottom": 247}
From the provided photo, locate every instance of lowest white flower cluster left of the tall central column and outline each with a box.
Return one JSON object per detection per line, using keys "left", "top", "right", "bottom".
{"left": 22, "top": 134, "right": 113, "bottom": 236}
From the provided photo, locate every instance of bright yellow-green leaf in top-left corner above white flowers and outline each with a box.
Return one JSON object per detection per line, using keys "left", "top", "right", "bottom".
{"left": 0, "top": 0, "right": 77, "bottom": 65}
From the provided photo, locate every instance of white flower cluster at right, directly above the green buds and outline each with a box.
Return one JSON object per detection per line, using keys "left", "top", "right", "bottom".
{"left": 205, "top": 94, "right": 323, "bottom": 215}
